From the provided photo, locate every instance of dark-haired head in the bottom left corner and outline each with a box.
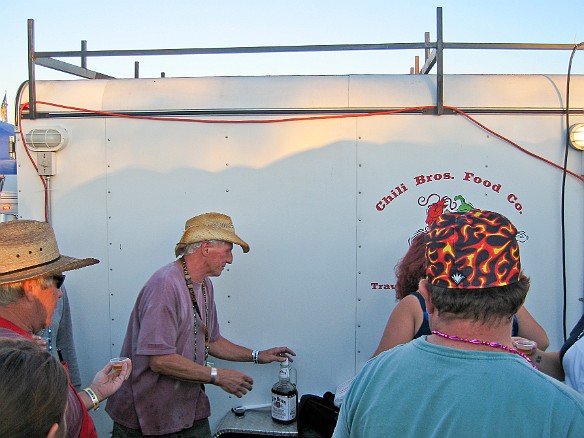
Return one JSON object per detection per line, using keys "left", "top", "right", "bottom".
{"left": 0, "top": 338, "right": 68, "bottom": 438}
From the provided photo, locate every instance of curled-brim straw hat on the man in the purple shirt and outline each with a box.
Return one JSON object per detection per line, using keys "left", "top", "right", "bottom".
{"left": 174, "top": 213, "right": 249, "bottom": 257}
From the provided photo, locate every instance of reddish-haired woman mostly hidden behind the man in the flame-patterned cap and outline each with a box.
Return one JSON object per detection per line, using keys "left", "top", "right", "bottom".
{"left": 372, "top": 233, "right": 550, "bottom": 357}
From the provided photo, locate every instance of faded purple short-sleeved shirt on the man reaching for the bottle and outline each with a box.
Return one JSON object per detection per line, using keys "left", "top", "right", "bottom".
{"left": 106, "top": 261, "right": 220, "bottom": 435}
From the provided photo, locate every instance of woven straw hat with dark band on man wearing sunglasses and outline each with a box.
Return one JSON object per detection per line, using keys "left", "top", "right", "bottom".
{"left": 0, "top": 220, "right": 99, "bottom": 284}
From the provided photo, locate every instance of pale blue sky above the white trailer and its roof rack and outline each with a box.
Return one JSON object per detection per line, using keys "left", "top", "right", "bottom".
{"left": 0, "top": 0, "right": 584, "bottom": 121}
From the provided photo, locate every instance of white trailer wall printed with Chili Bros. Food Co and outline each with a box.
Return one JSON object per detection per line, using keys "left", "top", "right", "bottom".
{"left": 17, "top": 75, "right": 584, "bottom": 436}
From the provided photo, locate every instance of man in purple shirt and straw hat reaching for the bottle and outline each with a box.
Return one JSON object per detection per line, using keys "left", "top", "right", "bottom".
{"left": 106, "top": 213, "right": 295, "bottom": 437}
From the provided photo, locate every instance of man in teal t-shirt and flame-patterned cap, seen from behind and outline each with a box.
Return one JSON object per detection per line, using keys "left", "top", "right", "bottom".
{"left": 333, "top": 210, "right": 584, "bottom": 438}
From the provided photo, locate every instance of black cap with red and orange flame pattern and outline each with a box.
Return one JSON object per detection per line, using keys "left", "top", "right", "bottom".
{"left": 426, "top": 210, "right": 521, "bottom": 289}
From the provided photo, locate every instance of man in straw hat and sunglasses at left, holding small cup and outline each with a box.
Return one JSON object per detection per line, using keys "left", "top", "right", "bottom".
{"left": 0, "top": 220, "right": 131, "bottom": 437}
